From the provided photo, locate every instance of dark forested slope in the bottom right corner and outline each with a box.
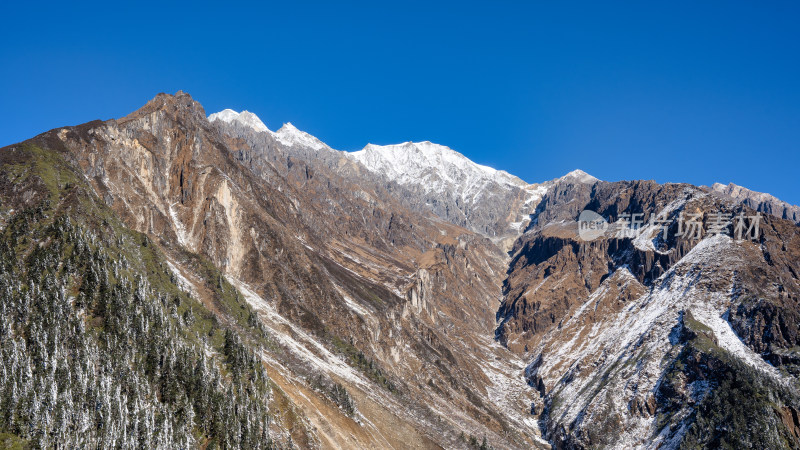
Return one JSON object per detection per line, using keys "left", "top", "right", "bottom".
{"left": 658, "top": 312, "right": 800, "bottom": 449}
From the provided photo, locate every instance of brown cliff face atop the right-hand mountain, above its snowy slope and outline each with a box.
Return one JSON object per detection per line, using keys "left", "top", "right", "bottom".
{"left": 498, "top": 182, "right": 692, "bottom": 347}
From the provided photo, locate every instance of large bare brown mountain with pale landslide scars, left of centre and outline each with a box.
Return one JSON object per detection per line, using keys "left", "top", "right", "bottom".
{"left": 4, "top": 93, "right": 538, "bottom": 448}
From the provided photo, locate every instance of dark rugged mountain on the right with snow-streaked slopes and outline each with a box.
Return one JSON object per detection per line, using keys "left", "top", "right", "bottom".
{"left": 497, "top": 181, "right": 800, "bottom": 448}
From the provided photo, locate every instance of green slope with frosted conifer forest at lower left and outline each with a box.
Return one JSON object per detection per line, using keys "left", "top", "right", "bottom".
{"left": 0, "top": 142, "right": 273, "bottom": 448}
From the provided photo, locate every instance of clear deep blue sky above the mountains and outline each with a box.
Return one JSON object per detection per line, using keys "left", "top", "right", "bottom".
{"left": 0, "top": 1, "right": 800, "bottom": 204}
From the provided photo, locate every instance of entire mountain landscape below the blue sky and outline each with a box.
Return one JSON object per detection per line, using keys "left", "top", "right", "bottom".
{"left": 0, "top": 92, "right": 800, "bottom": 449}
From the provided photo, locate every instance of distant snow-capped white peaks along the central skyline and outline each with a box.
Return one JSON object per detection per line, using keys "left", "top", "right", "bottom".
{"left": 209, "top": 110, "right": 556, "bottom": 242}
